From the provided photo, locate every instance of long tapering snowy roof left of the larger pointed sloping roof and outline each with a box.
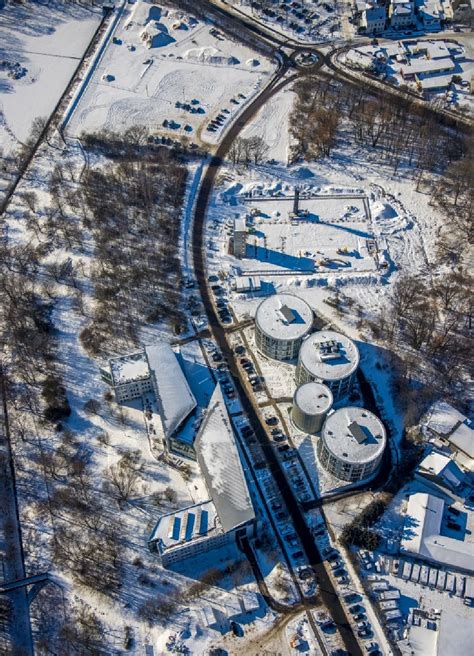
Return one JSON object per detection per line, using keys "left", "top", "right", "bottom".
{"left": 145, "top": 342, "right": 196, "bottom": 437}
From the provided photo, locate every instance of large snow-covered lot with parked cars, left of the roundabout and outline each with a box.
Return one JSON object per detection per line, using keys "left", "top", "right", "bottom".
{"left": 69, "top": 0, "right": 273, "bottom": 143}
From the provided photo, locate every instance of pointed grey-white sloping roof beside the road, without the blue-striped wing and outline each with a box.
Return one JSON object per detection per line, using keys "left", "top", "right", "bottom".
{"left": 194, "top": 384, "right": 255, "bottom": 532}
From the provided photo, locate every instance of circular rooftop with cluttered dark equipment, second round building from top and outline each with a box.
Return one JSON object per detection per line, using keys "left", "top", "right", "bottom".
{"left": 299, "top": 330, "right": 359, "bottom": 381}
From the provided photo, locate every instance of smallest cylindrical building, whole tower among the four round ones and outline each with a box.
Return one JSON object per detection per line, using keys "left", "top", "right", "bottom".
{"left": 291, "top": 383, "right": 332, "bottom": 434}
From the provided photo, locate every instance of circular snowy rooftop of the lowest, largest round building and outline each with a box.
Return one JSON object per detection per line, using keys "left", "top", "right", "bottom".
{"left": 321, "top": 407, "right": 387, "bottom": 465}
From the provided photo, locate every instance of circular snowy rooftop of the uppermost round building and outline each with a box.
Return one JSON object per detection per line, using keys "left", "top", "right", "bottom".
{"left": 255, "top": 294, "right": 313, "bottom": 340}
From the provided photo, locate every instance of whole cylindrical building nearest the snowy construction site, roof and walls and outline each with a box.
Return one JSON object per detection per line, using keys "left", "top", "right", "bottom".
{"left": 255, "top": 294, "right": 313, "bottom": 360}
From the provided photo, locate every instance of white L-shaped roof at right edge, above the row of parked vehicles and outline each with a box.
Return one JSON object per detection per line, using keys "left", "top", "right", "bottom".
{"left": 400, "top": 492, "right": 474, "bottom": 572}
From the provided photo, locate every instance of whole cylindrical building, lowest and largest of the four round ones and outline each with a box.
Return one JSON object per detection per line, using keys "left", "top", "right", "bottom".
{"left": 318, "top": 407, "right": 387, "bottom": 482}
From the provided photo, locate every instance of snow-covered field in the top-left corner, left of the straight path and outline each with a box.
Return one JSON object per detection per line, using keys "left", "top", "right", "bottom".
{"left": 0, "top": 1, "right": 101, "bottom": 151}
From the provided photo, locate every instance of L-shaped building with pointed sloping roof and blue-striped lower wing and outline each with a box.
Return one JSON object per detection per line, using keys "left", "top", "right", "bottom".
{"left": 148, "top": 385, "right": 256, "bottom": 567}
